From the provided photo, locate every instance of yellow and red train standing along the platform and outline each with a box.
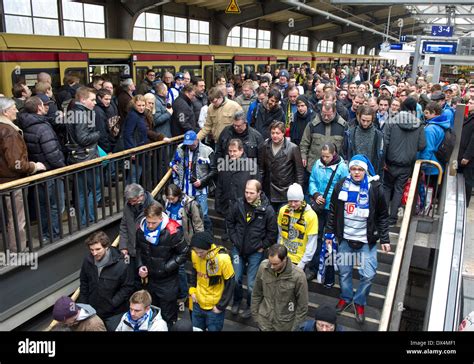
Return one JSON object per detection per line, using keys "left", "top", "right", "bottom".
{"left": 0, "top": 33, "right": 382, "bottom": 96}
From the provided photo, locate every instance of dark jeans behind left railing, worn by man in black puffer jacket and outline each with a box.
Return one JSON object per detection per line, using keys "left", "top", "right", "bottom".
{"left": 38, "top": 179, "right": 64, "bottom": 238}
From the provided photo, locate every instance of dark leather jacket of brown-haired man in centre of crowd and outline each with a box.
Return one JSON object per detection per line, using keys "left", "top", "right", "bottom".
{"left": 258, "top": 138, "right": 304, "bottom": 202}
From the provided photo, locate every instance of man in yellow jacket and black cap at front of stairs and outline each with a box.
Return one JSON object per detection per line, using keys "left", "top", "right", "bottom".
{"left": 189, "top": 232, "right": 235, "bottom": 331}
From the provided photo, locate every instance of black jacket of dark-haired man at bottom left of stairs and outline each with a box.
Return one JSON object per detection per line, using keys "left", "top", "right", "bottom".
{"left": 77, "top": 247, "right": 134, "bottom": 318}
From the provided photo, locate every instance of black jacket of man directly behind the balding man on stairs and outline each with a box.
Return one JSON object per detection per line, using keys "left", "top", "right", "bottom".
{"left": 215, "top": 156, "right": 258, "bottom": 216}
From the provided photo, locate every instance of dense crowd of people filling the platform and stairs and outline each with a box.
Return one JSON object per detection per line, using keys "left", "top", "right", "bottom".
{"left": 0, "top": 64, "right": 474, "bottom": 331}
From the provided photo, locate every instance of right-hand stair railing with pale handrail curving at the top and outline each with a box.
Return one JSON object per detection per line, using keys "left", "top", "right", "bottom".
{"left": 379, "top": 160, "right": 443, "bottom": 331}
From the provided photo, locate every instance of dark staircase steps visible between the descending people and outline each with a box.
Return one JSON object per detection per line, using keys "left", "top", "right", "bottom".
{"left": 183, "top": 198, "right": 398, "bottom": 331}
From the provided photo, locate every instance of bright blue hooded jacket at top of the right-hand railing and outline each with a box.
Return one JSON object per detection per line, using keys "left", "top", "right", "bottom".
{"left": 417, "top": 114, "right": 451, "bottom": 175}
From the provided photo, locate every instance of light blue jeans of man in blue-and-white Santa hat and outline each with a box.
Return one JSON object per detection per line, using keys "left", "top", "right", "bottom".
{"left": 337, "top": 239, "right": 377, "bottom": 306}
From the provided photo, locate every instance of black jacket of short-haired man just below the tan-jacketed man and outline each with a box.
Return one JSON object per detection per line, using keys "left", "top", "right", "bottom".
{"left": 216, "top": 125, "right": 264, "bottom": 160}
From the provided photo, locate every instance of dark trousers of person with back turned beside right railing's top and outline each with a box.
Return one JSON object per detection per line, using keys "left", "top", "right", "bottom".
{"left": 383, "top": 166, "right": 412, "bottom": 224}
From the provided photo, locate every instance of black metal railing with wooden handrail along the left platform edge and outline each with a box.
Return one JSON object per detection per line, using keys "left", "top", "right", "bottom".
{"left": 0, "top": 136, "right": 182, "bottom": 258}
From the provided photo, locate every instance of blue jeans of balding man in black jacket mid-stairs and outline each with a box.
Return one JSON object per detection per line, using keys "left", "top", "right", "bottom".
{"left": 232, "top": 246, "right": 263, "bottom": 307}
